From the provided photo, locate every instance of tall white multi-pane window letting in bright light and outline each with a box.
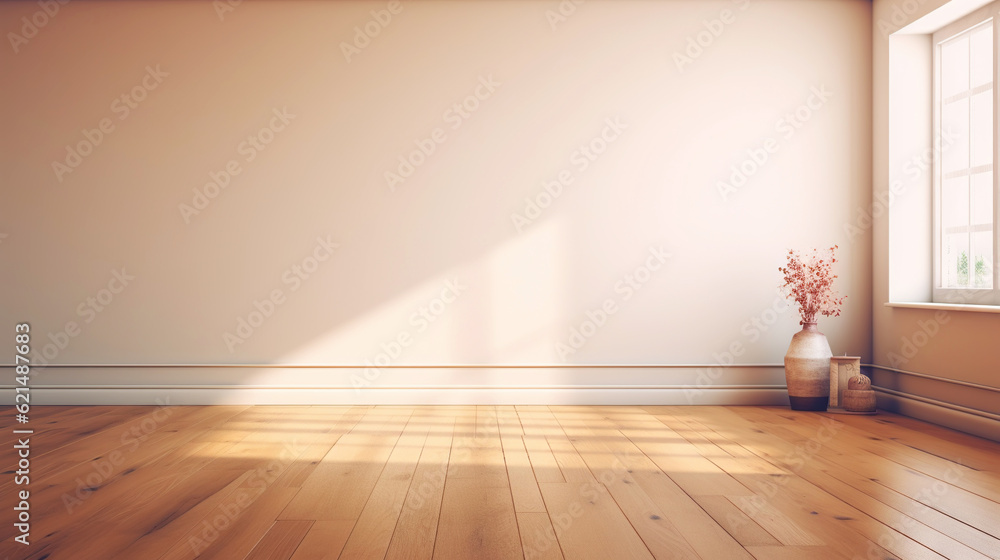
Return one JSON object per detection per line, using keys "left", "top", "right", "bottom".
{"left": 933, "top": 2, "right": 1000, "bottom": 305}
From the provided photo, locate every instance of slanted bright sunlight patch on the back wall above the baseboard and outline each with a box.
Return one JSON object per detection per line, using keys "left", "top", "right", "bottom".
{"left": 277, "top": 216, "right": 568, "bottom": 368}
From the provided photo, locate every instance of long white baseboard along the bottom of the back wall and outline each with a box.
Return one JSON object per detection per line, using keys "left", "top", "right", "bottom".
{"left": 0, "top": 365, "right": 788, "bottom": 406}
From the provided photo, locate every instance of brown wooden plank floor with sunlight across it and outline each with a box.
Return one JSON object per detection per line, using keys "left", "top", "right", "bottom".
{"left": 0, "top": 406, "right": 1000, "bottom": 560}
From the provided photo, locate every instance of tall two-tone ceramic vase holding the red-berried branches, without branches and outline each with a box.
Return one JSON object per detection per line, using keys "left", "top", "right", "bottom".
{"left": 785, "top": 323, "right": 833, "bottom": 410}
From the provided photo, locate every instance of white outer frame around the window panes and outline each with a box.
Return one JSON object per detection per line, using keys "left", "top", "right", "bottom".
{"left": 932, "top": 0, "right": 1000, "bottom": 305}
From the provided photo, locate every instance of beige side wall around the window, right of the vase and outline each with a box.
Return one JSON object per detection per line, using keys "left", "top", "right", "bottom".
{"left": 873, "top": 0, "right": 1000, "bottom": 439}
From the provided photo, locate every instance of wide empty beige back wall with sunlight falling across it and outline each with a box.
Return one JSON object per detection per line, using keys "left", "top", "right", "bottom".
{"left": 0, "top": 0, "right": 872, "bottom": 402}
